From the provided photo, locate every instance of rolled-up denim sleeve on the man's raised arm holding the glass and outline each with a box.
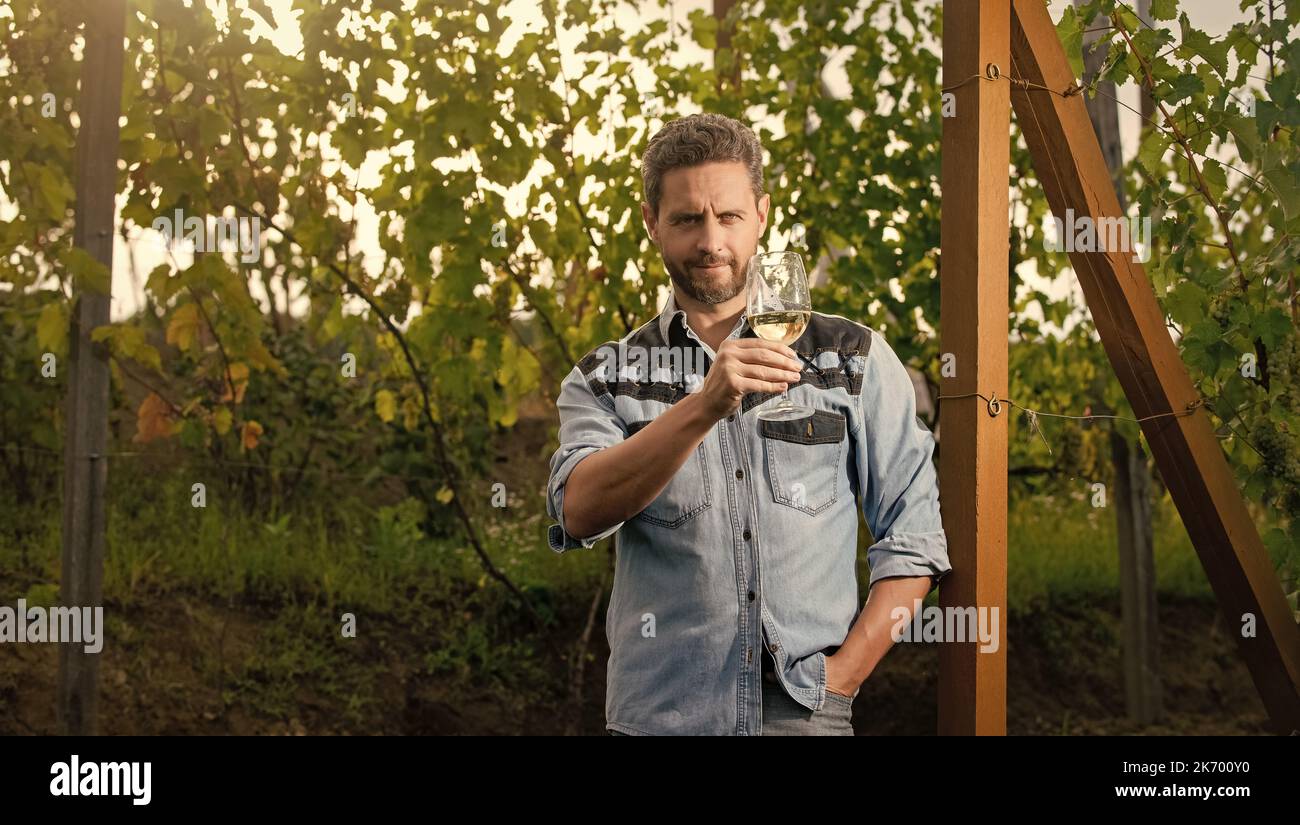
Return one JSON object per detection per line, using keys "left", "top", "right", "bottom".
{"left": 546, "top": 366, "right": 628, "bottom": 552}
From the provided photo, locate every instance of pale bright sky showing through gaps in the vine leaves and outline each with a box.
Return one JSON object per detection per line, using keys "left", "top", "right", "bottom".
{"left": 32, "top": 0, "right": 1268, "bottom": 331}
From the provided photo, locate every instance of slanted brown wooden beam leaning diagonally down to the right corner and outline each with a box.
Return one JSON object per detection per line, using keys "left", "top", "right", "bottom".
{"left": 1013, "top": 0, "right": 1300, "bottom": 734}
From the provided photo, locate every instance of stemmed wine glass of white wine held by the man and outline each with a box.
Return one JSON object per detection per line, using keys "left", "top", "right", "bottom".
{"left": 746, "top": 251, "right": 813, "bottom": 421}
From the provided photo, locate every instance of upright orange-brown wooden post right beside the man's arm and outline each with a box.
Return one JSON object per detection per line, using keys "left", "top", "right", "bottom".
{"left": 939, "top": 0, "right": 1011, "bottom": 735}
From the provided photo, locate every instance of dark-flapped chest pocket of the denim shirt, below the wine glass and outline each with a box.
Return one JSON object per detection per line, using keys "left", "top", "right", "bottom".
{"left": 759, "top": 409, "right": 845, "bottom": 516}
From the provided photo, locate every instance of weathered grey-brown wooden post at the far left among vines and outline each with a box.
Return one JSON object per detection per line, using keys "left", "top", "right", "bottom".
{"left": 57, "top": 0, "right": 126, "bottom": 735}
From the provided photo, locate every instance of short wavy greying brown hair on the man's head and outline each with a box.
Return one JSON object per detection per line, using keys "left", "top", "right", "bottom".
{"left": 641, "top": 112, "right": 763, "bottom": 220}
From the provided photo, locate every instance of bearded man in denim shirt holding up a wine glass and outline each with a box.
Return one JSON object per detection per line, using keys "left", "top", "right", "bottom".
{"left": 547, "top": 114, "right": 950, "bottom": 735}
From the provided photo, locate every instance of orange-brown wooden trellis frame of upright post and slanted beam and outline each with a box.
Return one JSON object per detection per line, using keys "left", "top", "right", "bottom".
{"left": 939, "top": 0, "right": 1300, "bottom": 734}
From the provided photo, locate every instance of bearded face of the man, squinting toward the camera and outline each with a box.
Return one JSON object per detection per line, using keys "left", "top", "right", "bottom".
{"left": 641, "top": 161, "right": 771, "bottom": 304}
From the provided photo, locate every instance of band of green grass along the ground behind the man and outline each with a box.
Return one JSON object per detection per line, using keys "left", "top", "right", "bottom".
{"left": 0, "top": 462, "right": 1284, "bottom": 615}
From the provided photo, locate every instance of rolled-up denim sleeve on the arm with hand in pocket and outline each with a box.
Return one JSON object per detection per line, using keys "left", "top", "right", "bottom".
{"left": 857, "top": 330, "right": 952, "bottom": 589}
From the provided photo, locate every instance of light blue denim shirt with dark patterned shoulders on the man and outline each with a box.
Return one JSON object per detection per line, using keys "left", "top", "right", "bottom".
{"left": 546, "top": 295, "right": 950, "bottom": 735}
